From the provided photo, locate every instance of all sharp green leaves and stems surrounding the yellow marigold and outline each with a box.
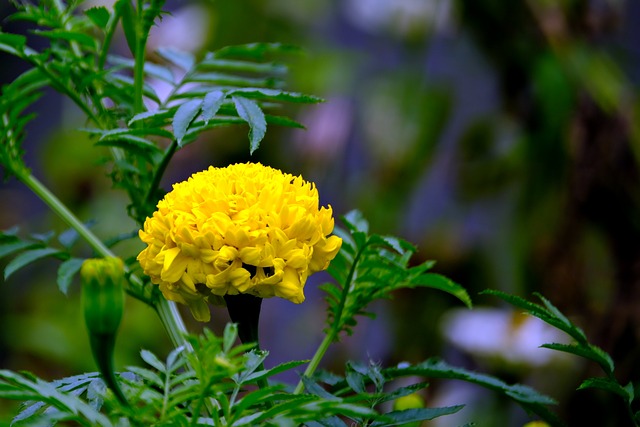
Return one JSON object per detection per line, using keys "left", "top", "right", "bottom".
{"left": 0, "top": 0, "right": 638, "bottom": 427}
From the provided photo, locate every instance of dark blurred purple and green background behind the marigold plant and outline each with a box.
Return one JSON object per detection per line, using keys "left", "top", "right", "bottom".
{"left": 0, "top": 0, "right": 640, "bottom": 426}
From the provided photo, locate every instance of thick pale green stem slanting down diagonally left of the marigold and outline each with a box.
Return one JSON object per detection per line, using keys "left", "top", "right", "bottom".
{"left": 18, "top": 173, "right": 193, "bottom": 351}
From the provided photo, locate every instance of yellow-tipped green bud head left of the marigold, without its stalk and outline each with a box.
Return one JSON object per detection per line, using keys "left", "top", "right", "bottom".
{"left": 80, "top": 257, "right": 125, "bottom": 334}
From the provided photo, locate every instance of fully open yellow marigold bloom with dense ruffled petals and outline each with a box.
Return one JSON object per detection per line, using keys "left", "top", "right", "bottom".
{"left": 138, "top": 163, "right": 342, "bottom": 321}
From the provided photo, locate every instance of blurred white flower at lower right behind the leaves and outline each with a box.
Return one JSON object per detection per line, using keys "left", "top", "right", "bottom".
{"left": 442, "top": 308, "right": 570, "bottom": 367}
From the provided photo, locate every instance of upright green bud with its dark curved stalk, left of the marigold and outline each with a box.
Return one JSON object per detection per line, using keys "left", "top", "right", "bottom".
{"left": 80, "top": 257, "right": 128, "bottom": 405}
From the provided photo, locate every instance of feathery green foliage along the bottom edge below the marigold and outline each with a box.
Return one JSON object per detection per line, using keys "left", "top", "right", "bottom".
{"left": 0, "top": 324, "right": 410, "bottom": 427}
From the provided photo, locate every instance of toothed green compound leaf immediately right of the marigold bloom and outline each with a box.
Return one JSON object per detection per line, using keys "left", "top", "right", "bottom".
{"left": 322, "top": 211, "right": 471, "bottom": 339}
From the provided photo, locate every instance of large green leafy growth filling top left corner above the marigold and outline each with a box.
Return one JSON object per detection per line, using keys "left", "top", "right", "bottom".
{"left": 0, "top": 0, "right": 320, "bottom": 223}
